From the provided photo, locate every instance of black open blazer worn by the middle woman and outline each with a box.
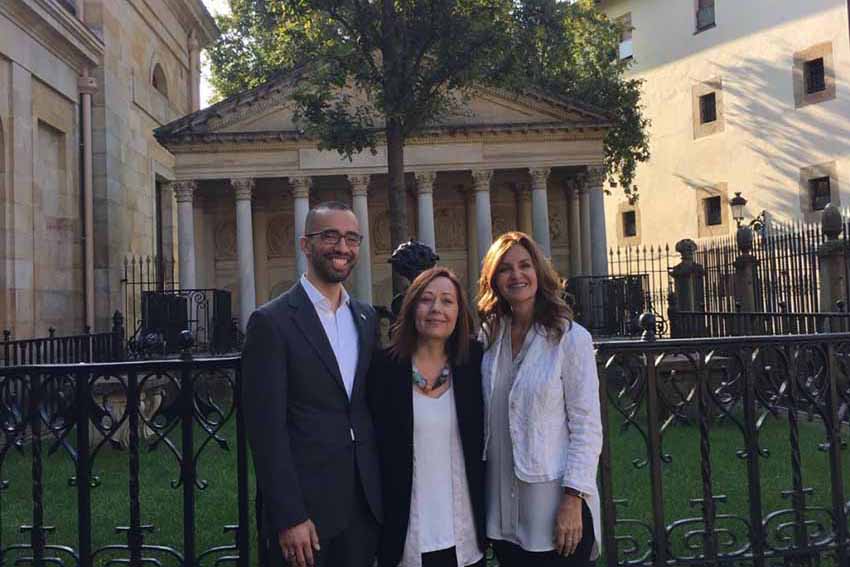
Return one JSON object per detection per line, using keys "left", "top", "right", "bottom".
{"left": 367, "top": 342, "right": 485, "bottom": 567}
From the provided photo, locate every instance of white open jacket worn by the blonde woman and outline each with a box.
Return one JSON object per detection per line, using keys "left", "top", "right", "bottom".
{"left": 481, "top": 319, "right": 602, "bottom": 547}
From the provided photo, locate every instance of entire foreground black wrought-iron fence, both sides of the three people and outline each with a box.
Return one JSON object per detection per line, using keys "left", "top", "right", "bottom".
{"left": 8, "top": 330, "right": 850, "bottom": 567}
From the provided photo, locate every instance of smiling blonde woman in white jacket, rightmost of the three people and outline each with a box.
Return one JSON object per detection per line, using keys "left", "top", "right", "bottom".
{"left": 478, "top": 232, "right": 602, "bottom": 567}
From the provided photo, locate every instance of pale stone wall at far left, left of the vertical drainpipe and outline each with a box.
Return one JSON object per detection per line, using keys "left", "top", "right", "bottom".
{"left": 0, "top": 35, "right": 84, "bottom": 337}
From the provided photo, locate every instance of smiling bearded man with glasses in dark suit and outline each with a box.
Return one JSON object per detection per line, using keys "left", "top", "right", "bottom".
{"left": 242, "top": 202, "right": 382, "bottom": 567}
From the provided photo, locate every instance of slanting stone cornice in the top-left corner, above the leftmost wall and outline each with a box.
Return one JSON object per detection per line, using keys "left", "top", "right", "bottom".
{"left": 0, "top": 0, "right": 104, "bottom": 69}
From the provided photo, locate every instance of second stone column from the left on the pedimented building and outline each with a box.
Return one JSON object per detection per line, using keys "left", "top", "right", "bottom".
{"left": 230, "top": 178, "right": 257, "bottom": 331}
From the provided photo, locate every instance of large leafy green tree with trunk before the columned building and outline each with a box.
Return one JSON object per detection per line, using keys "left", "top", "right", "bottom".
{"left": 209, "top": 0, "right": 648, "bottom": 286}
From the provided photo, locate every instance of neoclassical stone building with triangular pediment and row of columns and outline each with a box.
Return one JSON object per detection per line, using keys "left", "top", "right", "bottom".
{"left": 155, "top": 77, "right": 608, "bottom": 325}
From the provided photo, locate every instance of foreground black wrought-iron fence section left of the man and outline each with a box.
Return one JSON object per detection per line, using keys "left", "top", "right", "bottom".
{"left": 0, "top": 357, "right": 248, "bottom": 567}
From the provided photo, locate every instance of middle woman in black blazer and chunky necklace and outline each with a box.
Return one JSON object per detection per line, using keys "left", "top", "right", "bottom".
{"left": 368, "top": 266, "right": 484, "bottom": 567}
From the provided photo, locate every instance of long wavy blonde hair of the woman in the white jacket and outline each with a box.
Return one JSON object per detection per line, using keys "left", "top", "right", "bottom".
{"left": 477, "top": 231, "right": 573, "bottom": 348}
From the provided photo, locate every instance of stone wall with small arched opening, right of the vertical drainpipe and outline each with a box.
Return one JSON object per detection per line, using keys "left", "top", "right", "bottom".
{"left": 86, "top": 0, "right": 197, "bottom": 328}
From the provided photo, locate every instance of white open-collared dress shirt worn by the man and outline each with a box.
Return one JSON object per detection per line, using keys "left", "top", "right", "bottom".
{"left": 301, "top": 275, "right": 360, "bottom": 399}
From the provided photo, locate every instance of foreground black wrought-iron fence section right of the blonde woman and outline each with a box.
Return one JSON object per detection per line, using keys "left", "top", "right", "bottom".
{"left": 597, "top": 334, "right": 850, "bottom": 567}
